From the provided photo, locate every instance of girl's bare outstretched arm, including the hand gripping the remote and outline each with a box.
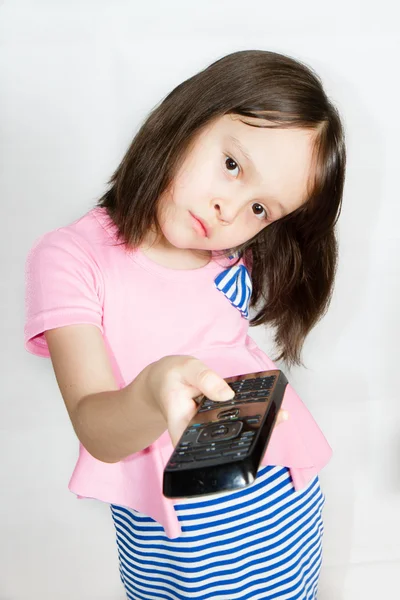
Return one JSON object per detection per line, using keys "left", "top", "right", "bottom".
{"left": 45, "top": 325, "right": 233, "bottom": 462}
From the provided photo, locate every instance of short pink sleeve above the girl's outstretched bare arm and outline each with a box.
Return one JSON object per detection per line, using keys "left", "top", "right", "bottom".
{"left": 25, "top": 229, "right": 103, "bottom": 356}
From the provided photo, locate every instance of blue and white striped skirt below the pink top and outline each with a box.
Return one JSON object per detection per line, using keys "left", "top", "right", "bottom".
{"left": 111, "top": 467, "right": 325, "bottom": 600}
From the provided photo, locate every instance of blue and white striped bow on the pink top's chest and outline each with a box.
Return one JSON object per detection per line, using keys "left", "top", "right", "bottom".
{"left": 214, "top": 265, "right": 253, "bottom": 319}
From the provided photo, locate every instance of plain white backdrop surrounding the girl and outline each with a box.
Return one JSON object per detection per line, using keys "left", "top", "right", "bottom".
{"left": 0, "top": 0, "right": 400, "bottom": 600}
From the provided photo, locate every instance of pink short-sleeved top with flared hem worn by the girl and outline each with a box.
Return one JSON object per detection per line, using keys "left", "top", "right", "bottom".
{"left": 25, "top": 208, "right": 332, "bottom": 538}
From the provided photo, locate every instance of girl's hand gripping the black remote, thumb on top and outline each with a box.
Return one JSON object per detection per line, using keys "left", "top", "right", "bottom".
{"left": 142, "top": 355, "right": 289, "bottom": 446}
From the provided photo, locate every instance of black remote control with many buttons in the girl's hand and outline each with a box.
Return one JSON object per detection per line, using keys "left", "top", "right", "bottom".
{"left": 163, "top": 369, "right": 288, "bottom": 498}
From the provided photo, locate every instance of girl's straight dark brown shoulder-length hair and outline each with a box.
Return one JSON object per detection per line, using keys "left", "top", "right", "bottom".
{"left": 98, "top": 50, "right": 346, "bottom": 365}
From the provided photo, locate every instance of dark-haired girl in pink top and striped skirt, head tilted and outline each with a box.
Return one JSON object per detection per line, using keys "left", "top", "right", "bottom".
{"left": 25, "top": 51, "right": 345, "bottom": 600}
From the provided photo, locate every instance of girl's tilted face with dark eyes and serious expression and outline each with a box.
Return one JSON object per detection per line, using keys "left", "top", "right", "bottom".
{"left": 159, "top": 115, "right": 315, "bottom": 250}
